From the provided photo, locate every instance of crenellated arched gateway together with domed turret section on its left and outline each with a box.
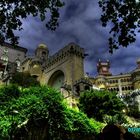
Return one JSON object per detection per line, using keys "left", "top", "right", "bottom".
{"left": 22, "top": 43, "right": 84, "bottom": 90}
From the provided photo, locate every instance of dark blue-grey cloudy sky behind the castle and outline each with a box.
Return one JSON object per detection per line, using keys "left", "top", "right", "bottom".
{"left": 14, "top": 0, "right": 140, "bottom": 76}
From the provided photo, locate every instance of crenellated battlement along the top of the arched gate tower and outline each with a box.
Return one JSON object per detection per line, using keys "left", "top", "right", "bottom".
{"left": 46, "top": 43, "right": 84, "bottom": 68}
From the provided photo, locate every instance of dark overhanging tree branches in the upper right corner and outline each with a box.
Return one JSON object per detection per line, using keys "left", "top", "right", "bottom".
{"left": 99, "top": 0, "right": 140, "bottom": 53}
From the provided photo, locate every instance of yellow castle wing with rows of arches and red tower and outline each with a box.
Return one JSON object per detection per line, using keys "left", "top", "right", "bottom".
{"left": 89, "top": 59, "right": 140, "bottom": 94}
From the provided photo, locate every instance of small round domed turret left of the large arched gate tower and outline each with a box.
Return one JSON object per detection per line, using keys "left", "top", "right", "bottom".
{"left": 35, "top": 44, "right": 49, "bottom": 61}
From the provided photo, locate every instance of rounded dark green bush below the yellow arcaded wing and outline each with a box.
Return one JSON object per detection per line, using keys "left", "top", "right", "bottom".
{"left": 79, "top": 90, "right": 125, "bottom": 121}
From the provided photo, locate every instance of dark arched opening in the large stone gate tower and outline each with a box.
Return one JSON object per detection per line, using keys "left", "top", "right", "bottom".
{"left": 48, "top": 70, "right": 65, "bottom": 90}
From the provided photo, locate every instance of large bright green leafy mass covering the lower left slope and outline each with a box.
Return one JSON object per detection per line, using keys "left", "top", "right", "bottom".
{"left": 0, "top": 86, "right": 103, "bottom": 140}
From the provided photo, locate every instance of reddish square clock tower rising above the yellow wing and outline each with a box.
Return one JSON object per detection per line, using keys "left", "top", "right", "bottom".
{"left": 97, "top": 60, "right": 112, "bottom": 76}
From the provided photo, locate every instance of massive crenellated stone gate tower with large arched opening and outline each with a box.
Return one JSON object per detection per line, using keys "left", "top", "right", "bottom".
{"left": 41, "top": 43, "right": 84, "bottom": 90}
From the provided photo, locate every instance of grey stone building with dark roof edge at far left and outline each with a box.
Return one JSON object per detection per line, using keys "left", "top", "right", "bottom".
{"left": 0, "top": 43, "right": 27, "bottom": 84}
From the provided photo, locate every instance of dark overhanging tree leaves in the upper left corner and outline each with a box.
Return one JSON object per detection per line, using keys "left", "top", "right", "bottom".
{"left": 0, "top": 0, "right": 64, "bottom": 44}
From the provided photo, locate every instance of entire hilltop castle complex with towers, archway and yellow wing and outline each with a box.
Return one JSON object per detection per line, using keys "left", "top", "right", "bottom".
{"left": 0, "top": 43, "right": 140, "bottom": 97}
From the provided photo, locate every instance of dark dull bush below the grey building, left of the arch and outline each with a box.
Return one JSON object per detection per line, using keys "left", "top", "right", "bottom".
{"left": 11, "top": 72, "right": 40, "bottom": 88}
